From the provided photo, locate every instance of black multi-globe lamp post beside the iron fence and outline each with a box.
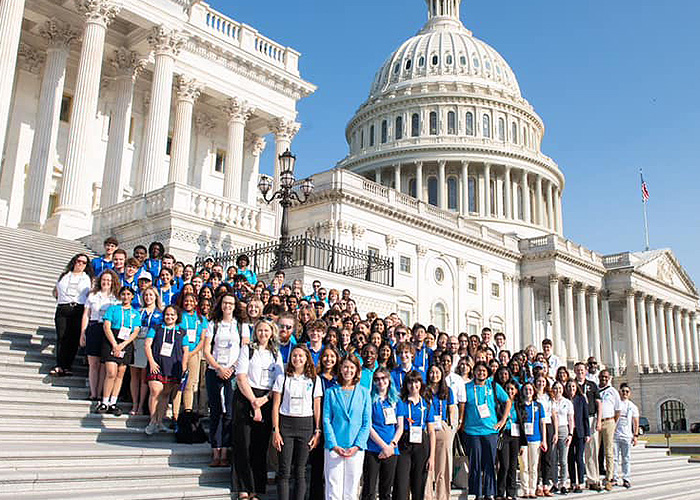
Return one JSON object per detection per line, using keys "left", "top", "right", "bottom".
{"left": 258, "top": 150, "right": 314, "bottom": 271}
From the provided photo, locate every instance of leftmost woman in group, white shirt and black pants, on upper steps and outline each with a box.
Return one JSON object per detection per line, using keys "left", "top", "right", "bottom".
{"left": 49, "top": 253, "right": 93, "bottom": 377}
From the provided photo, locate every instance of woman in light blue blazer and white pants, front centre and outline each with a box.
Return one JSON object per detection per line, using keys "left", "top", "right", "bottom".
{"left": 323, "top": 354, "right": 372, "bottom": 500}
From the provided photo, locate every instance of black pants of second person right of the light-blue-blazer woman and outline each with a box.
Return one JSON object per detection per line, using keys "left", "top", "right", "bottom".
{"left": 393, "top": 440, "right": 430, "bottom": 500}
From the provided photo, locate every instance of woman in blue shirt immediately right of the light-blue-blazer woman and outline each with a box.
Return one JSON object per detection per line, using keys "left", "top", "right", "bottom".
{"left": 361, "top": 368, "right": 403, "bottom": 500}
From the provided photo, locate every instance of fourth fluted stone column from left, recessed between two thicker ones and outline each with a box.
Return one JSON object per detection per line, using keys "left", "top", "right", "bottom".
{"left": 100, "top": 48, "right": 146, "bottom": 208}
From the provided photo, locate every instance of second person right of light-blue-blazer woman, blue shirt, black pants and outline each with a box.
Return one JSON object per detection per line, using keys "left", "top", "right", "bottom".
{"left": 393, "top": 370, "right": 435, "bottom": 500}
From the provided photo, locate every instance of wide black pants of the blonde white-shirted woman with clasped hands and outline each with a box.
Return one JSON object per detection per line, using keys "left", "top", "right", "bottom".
{"left": 233, "top": 389, "right": 272, "bottom": 495}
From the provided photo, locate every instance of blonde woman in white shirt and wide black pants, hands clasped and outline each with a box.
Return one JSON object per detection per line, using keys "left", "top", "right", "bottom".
{"left": 233, "top": 319, "right": 284, "bottom": 498}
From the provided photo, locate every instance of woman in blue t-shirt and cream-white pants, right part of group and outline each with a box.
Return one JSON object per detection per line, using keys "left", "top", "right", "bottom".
{"left": 518, "top": 382, "right": 547, "bottom": 498}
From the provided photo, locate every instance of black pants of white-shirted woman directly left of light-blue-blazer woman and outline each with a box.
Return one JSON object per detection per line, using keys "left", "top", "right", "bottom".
{"left": 277, "top": 415, "right": 314, "bottom": 500}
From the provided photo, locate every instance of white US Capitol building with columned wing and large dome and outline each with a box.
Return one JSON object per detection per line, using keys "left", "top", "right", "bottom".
{"left": 0, "top": 0, "right": 700, "bottom": 430}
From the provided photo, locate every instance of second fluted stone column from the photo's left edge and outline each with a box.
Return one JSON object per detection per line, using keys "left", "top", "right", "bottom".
{"left": 19, "top": 19, "right": 79, "bottom": 231}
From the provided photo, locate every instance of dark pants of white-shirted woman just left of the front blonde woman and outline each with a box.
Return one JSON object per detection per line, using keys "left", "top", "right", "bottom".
{"left": 204, "top": 368, "right": 233, "bottom": 448}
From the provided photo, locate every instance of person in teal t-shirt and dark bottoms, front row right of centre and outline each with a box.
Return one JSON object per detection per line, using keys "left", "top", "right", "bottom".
{"left": 464, "top": 362, "right": 512, "bottom": 498}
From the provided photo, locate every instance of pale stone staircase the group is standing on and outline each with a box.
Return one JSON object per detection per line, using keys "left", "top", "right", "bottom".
{"left": 0, "top": 227, "right": 700, "bottom": 500}
